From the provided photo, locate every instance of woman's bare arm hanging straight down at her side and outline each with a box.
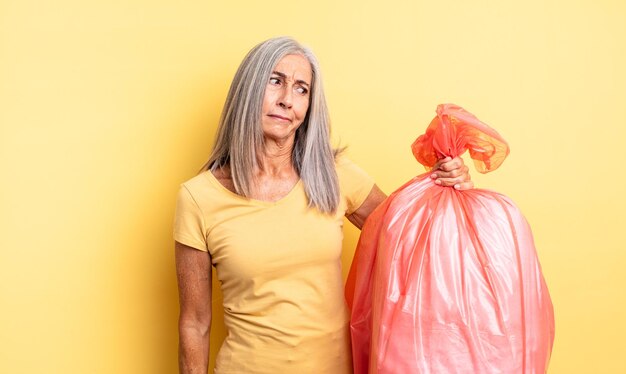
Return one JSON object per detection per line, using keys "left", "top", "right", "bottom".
{"left": 176, "top": 242, "right": 212, "bottom": 374}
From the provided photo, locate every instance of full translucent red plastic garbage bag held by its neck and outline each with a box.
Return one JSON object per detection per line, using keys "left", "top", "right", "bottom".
{"left": 346, "top": 104, "right": 554, "bottom": 374}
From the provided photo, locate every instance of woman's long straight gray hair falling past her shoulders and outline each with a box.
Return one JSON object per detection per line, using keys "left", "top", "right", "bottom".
{"left": 203, "top": 37, "right": 339, "bottom": 213}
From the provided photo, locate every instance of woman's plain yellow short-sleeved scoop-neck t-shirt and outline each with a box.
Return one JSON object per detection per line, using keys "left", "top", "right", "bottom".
{"left": 174, "top": 158, "right": 374, "bottom": 374}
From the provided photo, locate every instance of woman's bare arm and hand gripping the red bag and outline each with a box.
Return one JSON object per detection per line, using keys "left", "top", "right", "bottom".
{"left": 347, "top": 157, "right": 474, "bottom": 230}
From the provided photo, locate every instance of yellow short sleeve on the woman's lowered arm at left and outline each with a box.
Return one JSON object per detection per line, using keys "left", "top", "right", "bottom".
{"left": 174, "top": 184, "right": 208, "bottom": 252}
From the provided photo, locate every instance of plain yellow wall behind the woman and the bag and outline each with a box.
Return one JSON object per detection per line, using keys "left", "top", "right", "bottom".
{"left": 0, "top": 0, "right": 626, "bottom": 374}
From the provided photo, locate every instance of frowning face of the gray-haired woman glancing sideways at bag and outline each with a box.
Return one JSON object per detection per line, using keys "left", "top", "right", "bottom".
{"left": 261, "top": 55, "right": 312, "bottom": 142}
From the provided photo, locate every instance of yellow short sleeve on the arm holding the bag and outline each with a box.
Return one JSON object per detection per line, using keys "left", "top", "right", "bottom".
{"left": 336, "top": 157, "right": 374, "bottom": 215}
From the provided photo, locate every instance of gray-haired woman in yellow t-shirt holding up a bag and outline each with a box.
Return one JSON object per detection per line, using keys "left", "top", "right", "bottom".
{"left": 174, "top": 38, "right": 472, "bottom": 374}
